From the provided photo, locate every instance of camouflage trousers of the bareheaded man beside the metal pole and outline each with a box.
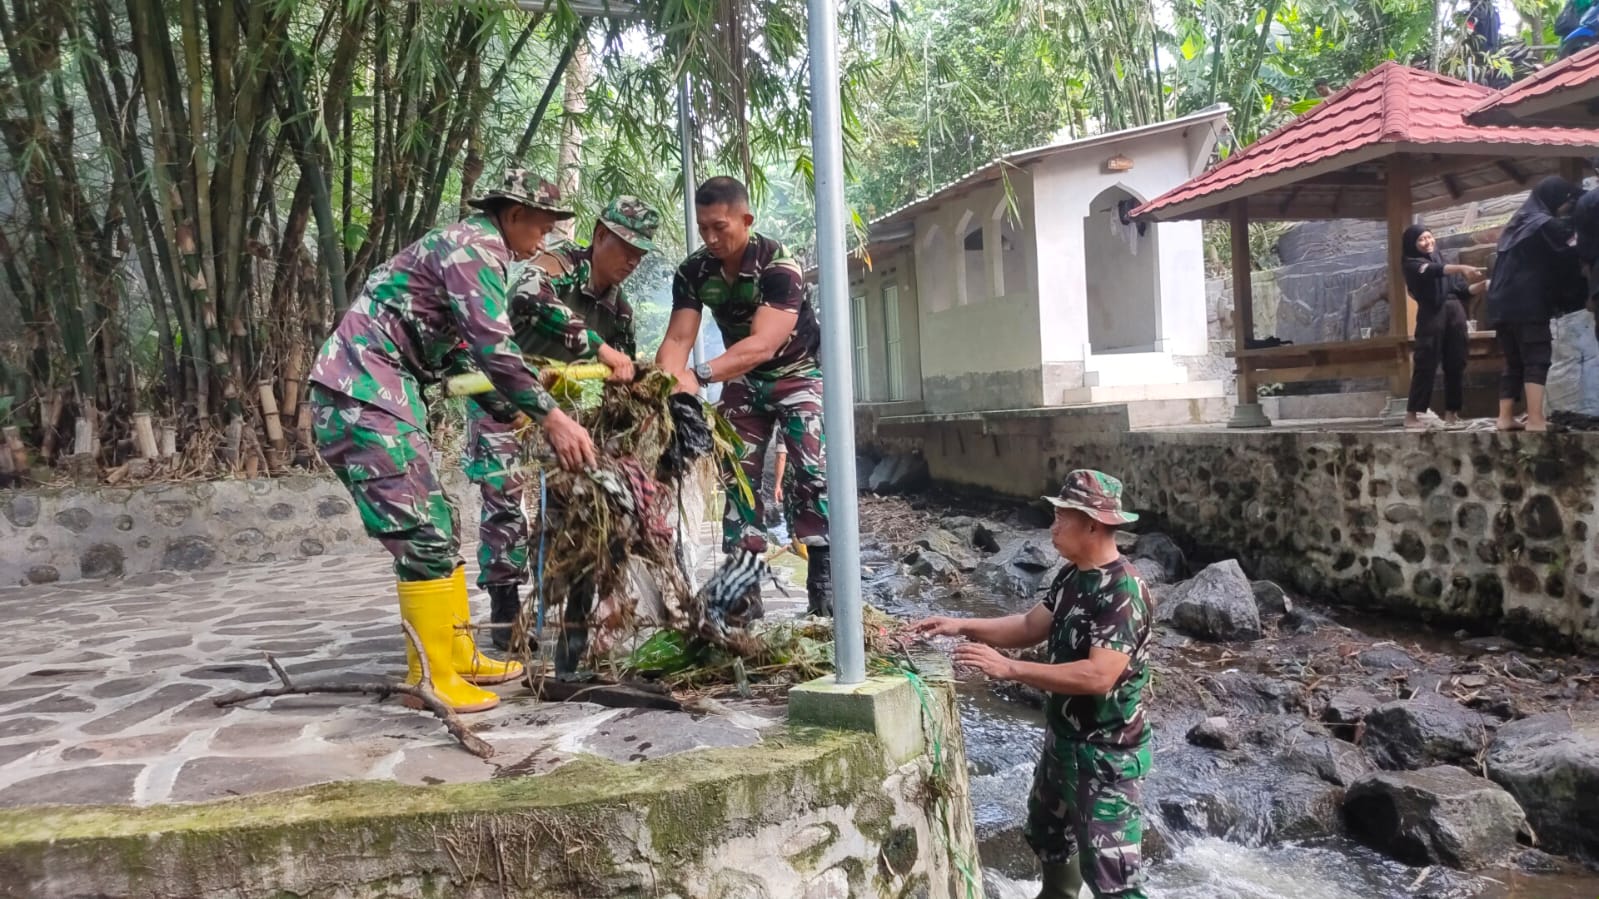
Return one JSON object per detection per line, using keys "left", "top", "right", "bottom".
{"left": 718, "top": 373, "right": 827, "bottom": 552}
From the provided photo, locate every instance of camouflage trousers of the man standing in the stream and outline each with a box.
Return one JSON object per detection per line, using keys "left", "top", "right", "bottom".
{"left": 1023, "top": 729, "right": 1150, "bottom": 899}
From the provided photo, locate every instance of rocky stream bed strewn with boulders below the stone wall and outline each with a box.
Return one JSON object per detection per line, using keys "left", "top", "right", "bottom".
{"left": 862, "top": 497, "right": 1599, "bottom": 896}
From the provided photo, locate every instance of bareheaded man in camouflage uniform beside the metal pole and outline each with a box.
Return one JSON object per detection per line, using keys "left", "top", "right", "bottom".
{"left": 656, "top": 178, "right": 833, "bottom": 616}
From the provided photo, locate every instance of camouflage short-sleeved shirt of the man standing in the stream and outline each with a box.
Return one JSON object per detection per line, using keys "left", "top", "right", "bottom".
{"left": 1044, "top": 557, "right": 1153, "bottom": 749}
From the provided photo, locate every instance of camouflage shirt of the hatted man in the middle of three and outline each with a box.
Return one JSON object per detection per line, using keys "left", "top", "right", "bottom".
{"left": 510, "top": 240, "right": 638, "bottom": 362}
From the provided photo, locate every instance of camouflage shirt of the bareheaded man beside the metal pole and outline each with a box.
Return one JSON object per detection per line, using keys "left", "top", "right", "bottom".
{"left": 672, "top": 232, "right": 822, "bottom": 381}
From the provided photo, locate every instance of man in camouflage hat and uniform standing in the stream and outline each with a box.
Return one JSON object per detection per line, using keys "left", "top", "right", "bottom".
{"left": 915, "top": 469, "right": 1153, "bottom": 899}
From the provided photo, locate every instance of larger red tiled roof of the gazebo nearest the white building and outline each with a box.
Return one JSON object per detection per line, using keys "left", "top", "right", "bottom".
{"left": 1134, "top": 62, "right": 1599, "bottom": 219}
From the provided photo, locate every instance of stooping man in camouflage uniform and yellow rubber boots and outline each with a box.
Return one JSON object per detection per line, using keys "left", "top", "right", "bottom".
{"left": 309, "top": 170, "right": 595, "bottom": 712}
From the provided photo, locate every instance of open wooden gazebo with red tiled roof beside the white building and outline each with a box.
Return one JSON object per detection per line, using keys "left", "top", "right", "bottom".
{"left": 1134, "top": 62, "right": 1599, "bottom": 427}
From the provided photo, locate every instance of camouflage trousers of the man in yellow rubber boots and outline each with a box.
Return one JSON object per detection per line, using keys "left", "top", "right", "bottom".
{"left": 309, "top": 384, "right": 461, "bottom": 581}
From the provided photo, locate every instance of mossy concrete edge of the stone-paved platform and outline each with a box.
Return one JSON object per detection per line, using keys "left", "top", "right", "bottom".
{"left": 0, "top": 728, "right": 883, "bottom": 899}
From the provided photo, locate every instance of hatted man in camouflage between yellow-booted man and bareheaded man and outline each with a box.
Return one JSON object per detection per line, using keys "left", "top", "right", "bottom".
{"left": 467, "top": 197, "right": 660, "bottom": 673}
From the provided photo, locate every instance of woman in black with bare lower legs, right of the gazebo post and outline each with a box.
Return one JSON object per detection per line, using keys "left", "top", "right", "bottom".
{"left": 1487, "top": 176, "right": 1588, "bottom": 430}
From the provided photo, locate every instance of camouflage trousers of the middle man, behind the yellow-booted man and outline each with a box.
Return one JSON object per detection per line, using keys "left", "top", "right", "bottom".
{"left": 465, "top": 405, "right": 529, "bottom": 587}
